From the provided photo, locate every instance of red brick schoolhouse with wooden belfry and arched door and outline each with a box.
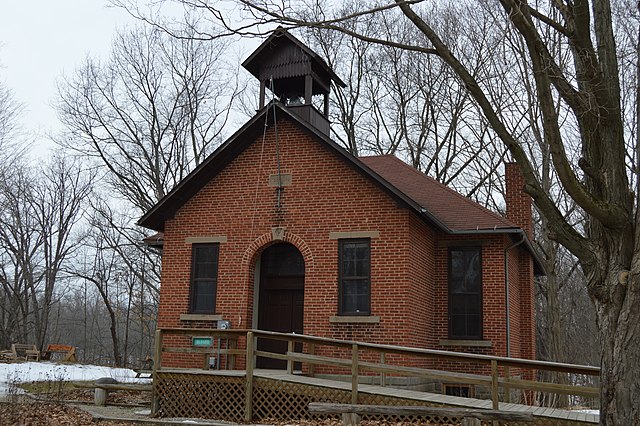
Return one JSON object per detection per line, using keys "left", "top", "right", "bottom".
{"left": 139, "top": 30, "right": 541, "bottom": 367}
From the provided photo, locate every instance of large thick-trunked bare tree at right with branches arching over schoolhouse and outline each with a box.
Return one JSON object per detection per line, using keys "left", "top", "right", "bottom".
{"left": 116, "top": 0, "right": 640, "bottom": 424}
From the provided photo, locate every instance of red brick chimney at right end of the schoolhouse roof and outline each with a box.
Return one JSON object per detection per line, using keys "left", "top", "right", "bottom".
{"left": 504, "top": 163, "right": 533, "bottom": 238}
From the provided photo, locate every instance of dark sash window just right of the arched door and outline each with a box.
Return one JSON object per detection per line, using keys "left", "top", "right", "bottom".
{"left": 338, "top": 238, "right": 371, "bottom": 315}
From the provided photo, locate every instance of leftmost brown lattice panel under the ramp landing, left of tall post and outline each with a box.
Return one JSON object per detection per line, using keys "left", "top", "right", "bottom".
{"left": 154, "top": 373, "right": 245, "bottom": 422}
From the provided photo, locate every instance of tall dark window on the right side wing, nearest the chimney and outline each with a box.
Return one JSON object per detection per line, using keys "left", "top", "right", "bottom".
{"left": 449, "top": 247, "right": 482, "bottom": 340}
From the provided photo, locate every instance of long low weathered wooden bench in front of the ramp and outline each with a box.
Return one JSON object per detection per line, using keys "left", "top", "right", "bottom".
{"left": 309, "top": 402, "right": 533, "bottom": 426}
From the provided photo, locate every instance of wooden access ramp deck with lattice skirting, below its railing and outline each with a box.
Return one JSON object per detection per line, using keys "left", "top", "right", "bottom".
{"left": 154, "top": 369, "right": 599, "bottom": 426}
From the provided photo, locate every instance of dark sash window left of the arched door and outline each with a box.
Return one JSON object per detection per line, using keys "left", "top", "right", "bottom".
{"left": 189, "top": 244, "right": 219, "bottom": 314}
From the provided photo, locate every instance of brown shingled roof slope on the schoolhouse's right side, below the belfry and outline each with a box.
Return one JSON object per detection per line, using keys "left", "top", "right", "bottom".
{"left": 359, "top": 155, "right": 518, "bottom": 232}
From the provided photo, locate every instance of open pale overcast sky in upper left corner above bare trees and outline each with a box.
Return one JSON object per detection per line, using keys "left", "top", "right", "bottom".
{"left": 0, "top": 0, "right": 134, "bottom": 153}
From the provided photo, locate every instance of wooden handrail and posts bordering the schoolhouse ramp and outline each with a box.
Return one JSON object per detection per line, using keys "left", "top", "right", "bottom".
{"left": 153, "top": 328, "right": 600, "bottom": 421}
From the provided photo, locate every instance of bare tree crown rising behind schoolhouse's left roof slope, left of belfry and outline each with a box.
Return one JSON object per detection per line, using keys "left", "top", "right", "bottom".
{"left": 57, "top": 28, "right": 239, "bottom": 212}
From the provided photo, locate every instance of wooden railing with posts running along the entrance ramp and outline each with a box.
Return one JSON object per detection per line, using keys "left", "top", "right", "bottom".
{"left": 154, "top": 328, "right": 600, "bottom": 421}
